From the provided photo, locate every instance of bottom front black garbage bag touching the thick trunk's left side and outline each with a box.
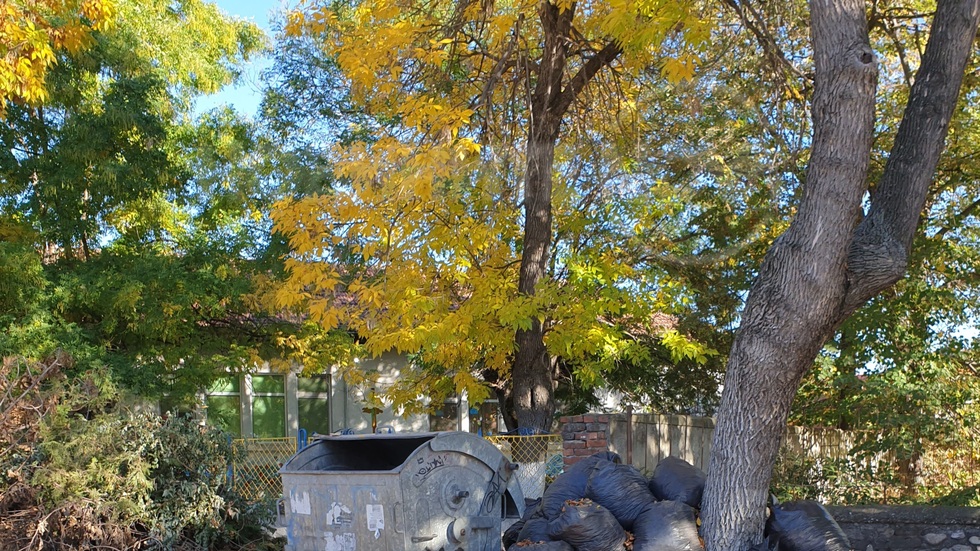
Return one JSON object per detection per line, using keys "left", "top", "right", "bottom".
{"left": 633, "top": 501, "right": 702, "bottom": 551}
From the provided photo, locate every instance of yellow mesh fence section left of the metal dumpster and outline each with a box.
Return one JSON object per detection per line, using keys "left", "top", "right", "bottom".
{"left": 231, "top": 438, "right": 296, "bottom": 501}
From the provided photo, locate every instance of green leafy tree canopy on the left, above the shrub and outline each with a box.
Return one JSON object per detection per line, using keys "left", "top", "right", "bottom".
{"left": 0, "top": 0, "right": 334, "bottom": 401}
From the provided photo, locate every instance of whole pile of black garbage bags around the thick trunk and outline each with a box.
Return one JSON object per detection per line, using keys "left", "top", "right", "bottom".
{"left": 503, "top": 452, "right": 850, "bottom": 551}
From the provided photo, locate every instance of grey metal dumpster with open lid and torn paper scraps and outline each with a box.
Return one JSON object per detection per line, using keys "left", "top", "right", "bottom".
{"left": 279, "top": 432, "right": 524, "bottom": 551}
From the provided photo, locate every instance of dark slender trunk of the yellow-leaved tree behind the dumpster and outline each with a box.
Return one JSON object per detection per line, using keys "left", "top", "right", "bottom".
{"left": 511, "top": 1, "right": 620, "bottom": 432}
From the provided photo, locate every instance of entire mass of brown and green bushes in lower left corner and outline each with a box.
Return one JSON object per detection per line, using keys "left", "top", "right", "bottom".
{"left": 0, "top": 357, "right": 274, "bottom": 549}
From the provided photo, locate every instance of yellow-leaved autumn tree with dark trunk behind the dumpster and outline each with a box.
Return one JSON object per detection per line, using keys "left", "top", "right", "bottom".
{"left": 275, "top": 2, "right": 707, "bottom": 431}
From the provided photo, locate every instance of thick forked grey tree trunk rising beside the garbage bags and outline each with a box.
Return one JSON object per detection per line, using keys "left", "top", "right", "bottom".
{"left": 702, "top": 0, "right": 980, "bottom": 551}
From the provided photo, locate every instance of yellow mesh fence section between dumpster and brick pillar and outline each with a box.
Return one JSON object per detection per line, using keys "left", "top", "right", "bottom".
{"left": 485, "top": 434, "right": 564, "bottom": 499}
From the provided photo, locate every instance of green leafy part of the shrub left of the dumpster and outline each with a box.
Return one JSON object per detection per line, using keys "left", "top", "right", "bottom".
{"left": 32, "top": 413, "right": 273, "bottom": 549}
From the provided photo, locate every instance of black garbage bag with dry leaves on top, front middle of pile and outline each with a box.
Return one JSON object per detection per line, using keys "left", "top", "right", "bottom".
{"left": 548, "top": 499, "right": 626, "bottom": 551}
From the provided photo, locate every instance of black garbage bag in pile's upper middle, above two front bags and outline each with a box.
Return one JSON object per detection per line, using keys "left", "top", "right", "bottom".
{"left": 585, "top": 461, "right": 656, "bottom": 530}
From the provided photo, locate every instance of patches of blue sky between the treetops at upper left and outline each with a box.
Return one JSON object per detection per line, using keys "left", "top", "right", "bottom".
{"left": 191, "top": 0, "right": 284, "bottom": 117}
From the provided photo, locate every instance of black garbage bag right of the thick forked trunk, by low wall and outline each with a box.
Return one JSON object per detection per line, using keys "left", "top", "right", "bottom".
{"left": 766, "top": 498, "right": 851, "bottom": 551}
